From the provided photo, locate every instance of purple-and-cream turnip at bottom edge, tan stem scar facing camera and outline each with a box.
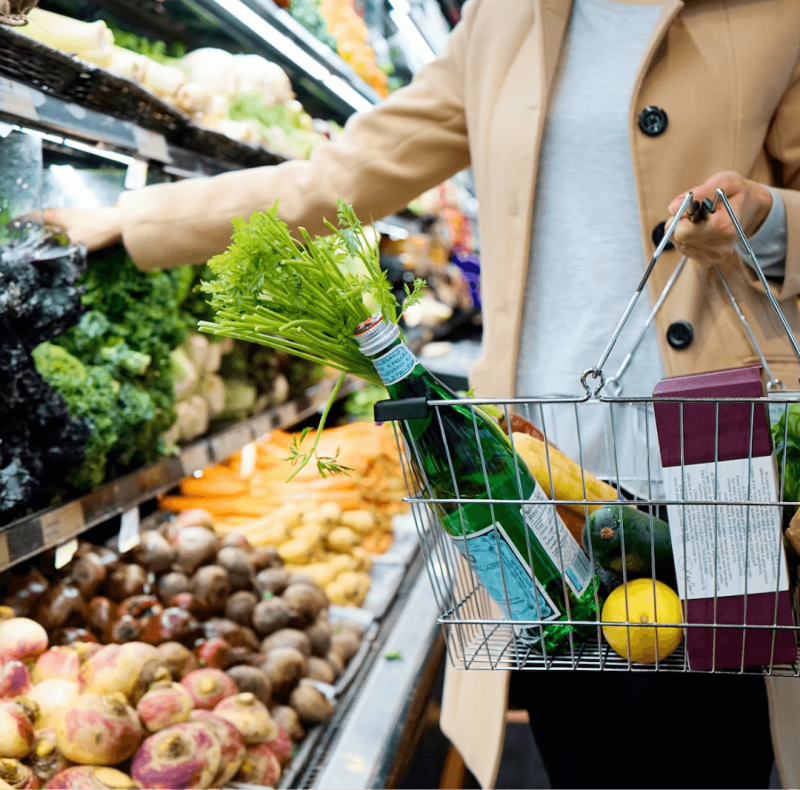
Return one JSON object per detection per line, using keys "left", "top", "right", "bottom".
{"left": 131, "top": 722, "right": 222, "bottom": 790}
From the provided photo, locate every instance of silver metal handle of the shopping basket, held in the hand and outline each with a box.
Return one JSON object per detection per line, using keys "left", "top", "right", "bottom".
{"left": 581, "top": 188, "right": 800, "bottom": 397}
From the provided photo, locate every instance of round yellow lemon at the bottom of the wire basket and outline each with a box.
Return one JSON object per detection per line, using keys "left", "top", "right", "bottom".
{"left": 600, "top": 579, "right": 683, "bottom": 664}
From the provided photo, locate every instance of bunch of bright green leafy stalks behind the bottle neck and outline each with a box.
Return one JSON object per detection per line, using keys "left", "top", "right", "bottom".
{"left": 199, "top": 201, "right": 424, "bottom": 475}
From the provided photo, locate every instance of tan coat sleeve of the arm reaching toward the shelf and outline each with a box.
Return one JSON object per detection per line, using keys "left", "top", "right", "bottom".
{"left": 119, "top": 6, "right": 479, "bottom": 269}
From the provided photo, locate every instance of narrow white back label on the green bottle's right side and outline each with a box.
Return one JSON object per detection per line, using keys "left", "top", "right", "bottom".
{"left": 522, "top": 480, "right": 592, "bottom": 598}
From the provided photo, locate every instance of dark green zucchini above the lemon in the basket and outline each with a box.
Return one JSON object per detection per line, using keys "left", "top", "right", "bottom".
{"left": 583, "top": 505, "right": 676, "bottom": 587}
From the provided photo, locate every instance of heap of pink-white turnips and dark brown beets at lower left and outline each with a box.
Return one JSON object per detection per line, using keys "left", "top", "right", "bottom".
{"left": 0, "top": 512, "right": 363, "bottom": 788}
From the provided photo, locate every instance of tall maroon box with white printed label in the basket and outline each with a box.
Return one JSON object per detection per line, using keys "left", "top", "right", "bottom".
{"left": 653, "top": 366, "right": 797, "bottom": 670}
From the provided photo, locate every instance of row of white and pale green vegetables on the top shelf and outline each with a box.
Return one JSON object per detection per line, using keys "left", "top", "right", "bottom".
{"left": 17, "top": 8, "right": 339, "bottom": 159}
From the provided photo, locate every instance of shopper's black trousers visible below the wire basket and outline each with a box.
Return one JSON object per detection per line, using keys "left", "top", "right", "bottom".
{"left": 510, "top": 671, "right": 773, "bottom": 790}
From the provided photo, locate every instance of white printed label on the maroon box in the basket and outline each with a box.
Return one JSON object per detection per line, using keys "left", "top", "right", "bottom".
{"left": 664, "top": 455, "right": 789, "bottom": 599}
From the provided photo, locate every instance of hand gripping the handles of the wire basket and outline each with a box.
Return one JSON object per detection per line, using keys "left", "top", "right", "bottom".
{"left": 669, "top": 171, "right": 772, "bottom": 266}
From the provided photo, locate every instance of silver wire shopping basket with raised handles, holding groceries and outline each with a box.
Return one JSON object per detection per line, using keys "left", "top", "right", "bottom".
{"left": 376, "top": 190, "right": 800, "bottom": 676}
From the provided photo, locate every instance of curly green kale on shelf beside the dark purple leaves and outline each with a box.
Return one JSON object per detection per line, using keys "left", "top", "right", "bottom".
{"left": 34, "top": 245, "right": 194, "bottom": 488}
